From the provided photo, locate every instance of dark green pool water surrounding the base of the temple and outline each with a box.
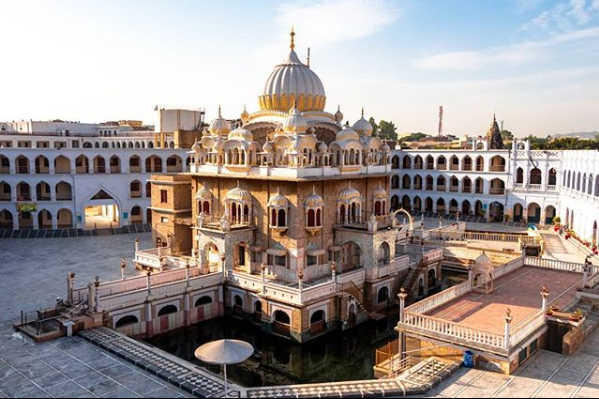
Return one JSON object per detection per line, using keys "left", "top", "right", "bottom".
{"left": 148, "top": 273, "right": 464, "bottom": 387}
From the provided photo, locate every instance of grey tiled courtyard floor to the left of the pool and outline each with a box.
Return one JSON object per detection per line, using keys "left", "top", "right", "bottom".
{"left": 0, "top": 233, "right": 186, "bottom": 398}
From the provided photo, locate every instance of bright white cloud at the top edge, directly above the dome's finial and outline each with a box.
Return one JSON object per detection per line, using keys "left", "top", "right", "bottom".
{"left": 276, "top": 0, "right": 399, "bottom": 45}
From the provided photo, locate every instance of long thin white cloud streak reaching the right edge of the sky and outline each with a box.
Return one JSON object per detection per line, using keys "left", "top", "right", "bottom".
{"left": 414, "top": 28, "right": 599, "bottom": 70}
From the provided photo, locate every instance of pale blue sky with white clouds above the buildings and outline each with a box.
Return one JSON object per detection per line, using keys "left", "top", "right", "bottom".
{"left": 0, "top": 0, "right": 599, "bottom": 137}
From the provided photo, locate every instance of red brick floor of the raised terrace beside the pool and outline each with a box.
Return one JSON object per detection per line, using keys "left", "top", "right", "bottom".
{"left": 428, "top": 267, "right": 582, "bottom": 334}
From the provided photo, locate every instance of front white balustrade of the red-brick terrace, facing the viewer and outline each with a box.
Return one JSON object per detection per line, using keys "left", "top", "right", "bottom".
{"left": 400, "top": 313, "right": 507, "bottom": 351}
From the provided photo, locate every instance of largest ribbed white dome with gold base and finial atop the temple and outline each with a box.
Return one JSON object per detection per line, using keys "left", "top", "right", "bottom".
{"left": 258, "top": 30, "right": 326, "bottom": 112}
